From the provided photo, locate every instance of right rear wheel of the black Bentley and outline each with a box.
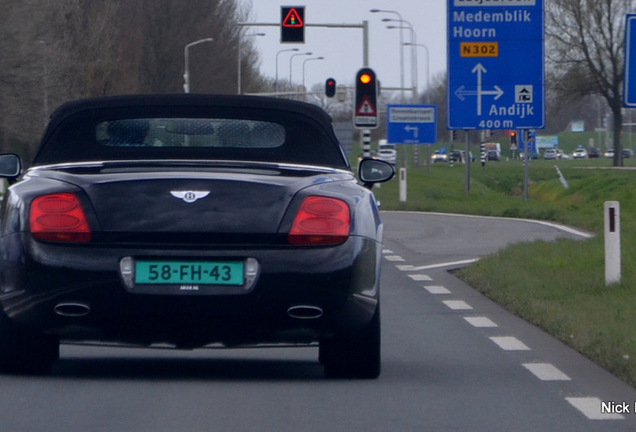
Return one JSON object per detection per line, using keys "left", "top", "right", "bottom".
{"left": 319, "top": 304, "right": 381, "bottom": 379}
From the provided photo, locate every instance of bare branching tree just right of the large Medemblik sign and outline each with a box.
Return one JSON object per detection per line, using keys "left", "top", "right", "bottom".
{"left": 546, "top": 0, "right": 636, "bottom": 166}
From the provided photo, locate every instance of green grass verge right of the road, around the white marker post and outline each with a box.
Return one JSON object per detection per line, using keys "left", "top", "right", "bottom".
{"left": 374, "top": 153, "right": 636, "bottom": 386}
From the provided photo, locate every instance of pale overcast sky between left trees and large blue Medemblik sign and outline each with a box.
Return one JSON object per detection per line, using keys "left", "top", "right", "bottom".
{"left": 241, "top": 0, "right": 447, "bottom": 91}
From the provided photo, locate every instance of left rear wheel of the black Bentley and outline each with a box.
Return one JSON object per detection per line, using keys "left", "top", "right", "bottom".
{"left": 0, "top": 312, "right": 60, "bottom": 375}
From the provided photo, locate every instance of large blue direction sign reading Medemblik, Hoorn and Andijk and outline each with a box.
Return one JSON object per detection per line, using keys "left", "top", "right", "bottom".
{"left": 448, "top": 0, "right": 545, "bottom": 129}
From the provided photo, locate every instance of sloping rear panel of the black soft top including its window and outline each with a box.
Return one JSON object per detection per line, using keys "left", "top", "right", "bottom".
{"left": 33, "top": 106, "right": 349, "bottom": 169}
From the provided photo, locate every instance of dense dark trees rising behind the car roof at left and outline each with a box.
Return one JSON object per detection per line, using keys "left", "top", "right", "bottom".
{"left": 0, "top": 0, "right": 266, "bottom": 157}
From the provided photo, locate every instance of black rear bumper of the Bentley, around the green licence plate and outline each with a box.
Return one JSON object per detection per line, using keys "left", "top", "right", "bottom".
{"left": 0, "top": 236, "right": 381, "bottom": 347}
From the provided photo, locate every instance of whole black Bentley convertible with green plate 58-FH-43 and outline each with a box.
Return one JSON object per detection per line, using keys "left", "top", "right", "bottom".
{"left": 0, "top": 95, "right": 393, "bottom": 378}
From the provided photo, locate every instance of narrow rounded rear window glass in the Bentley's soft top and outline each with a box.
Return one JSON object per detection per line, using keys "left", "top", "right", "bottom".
{"left": 95, "top": 118, "right": 285, "bottom": 149}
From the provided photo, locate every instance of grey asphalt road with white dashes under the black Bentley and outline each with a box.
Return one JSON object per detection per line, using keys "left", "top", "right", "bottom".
{"left": 0, "top": 213, "right": 636, "bottom": 432}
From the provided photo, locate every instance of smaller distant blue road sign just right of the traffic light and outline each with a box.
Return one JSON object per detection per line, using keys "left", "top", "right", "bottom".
{"left": 386, "top": 105, "right": 437, "bottom": 144}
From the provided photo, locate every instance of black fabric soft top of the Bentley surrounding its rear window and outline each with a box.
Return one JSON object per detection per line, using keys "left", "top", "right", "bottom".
{"left": 34, "top": 94, "right": 348, "bottom": 168}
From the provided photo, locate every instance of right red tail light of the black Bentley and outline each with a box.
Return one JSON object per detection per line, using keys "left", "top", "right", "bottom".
{"left": 289, "top": 196, "right": 351, "bottom": 245}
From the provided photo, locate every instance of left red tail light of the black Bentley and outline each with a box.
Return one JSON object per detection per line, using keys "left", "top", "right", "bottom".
{"left": 29, "top": 193, "right": 91, "bottom": 243}
